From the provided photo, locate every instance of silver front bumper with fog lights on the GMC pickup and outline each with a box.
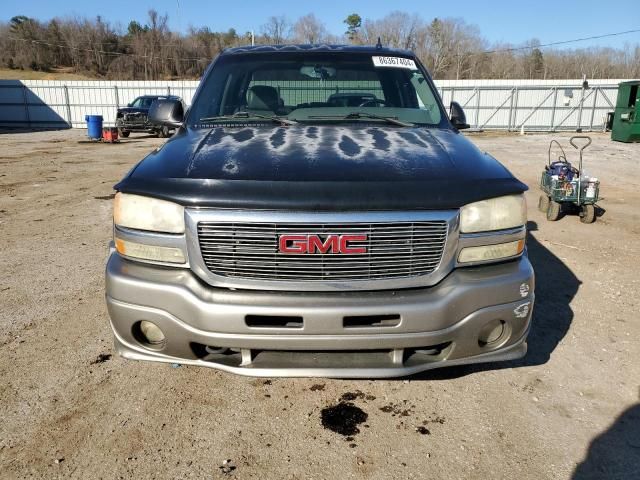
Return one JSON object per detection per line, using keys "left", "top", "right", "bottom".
{"left": 106, "top": 253, "right": 534, "bottom": 378}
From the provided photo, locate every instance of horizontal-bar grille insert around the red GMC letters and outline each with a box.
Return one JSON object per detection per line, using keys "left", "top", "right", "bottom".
{"left": 197, "top": 220, "right": 448, "bottom": 281}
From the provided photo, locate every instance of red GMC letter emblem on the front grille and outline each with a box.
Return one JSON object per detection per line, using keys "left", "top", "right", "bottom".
{"left": 278, "top": 234, "right": 367, "bottom": 255}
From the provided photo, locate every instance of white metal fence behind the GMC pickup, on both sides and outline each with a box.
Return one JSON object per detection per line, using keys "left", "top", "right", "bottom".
{"left": 0, "top": 80, "right": 623, "bottom": 131}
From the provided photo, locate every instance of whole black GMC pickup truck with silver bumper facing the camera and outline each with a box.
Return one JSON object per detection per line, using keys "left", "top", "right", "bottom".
{"left": 106, "top": 45, "right": 534, "bottom": 377}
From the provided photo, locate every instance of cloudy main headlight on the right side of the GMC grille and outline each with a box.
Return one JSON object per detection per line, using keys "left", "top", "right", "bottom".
{"left": 460, "top": 195, "right": 527, "bottom": 233}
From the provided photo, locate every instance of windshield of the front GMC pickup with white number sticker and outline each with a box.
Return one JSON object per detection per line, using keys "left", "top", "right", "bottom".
{"left": 188, "top": 52, "right": 443, "bottom": 128}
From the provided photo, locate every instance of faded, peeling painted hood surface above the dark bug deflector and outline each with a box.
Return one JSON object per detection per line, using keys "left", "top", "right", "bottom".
{"left": 133, "top": 126, "right": 508, "bottom": 182}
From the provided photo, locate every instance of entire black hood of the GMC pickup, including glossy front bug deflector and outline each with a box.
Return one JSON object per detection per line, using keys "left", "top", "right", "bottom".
{"left": 116, "top": 124, "right": 527, "bottom": 210}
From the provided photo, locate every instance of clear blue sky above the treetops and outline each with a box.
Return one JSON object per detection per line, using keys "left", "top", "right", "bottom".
{"left": 5, "top": 0, "right": 640, "bottom": 48}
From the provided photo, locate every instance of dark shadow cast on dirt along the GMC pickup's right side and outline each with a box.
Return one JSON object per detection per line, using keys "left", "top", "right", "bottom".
{"left": 412, "top": 222, "right": 582, "bottom": 380}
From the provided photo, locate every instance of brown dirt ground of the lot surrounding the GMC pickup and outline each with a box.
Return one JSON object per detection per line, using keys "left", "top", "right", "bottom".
{"left": 0, "top": 131, "right": 640, "bottom": 480}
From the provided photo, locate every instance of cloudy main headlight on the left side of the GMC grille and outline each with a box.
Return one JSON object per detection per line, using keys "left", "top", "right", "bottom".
{"left": 113, "top": 193, "right": 184, "bottom": 233}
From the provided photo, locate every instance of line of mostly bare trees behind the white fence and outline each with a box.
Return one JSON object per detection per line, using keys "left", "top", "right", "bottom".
{"left": 0, "top": 10, "right": 640, "bottom": 80}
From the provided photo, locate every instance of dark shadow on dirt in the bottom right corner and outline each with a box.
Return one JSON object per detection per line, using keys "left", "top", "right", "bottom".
{"left": 571, "top": 404, "right": 640, "bottom": 480}
